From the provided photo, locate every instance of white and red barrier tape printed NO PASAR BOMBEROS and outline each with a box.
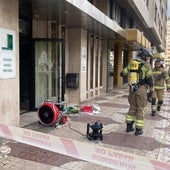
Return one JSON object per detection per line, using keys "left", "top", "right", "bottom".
{"left": 0, "top": 124, "right": 170, "bottom": 170}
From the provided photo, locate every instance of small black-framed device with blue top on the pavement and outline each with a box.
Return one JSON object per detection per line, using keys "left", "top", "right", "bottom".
{"left": 86, "top": 121, "right": 103, "bottom": 140}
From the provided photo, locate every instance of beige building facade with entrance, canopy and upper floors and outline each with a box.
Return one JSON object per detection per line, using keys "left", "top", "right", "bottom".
{"left": 0, "top": 0, "right": 167, "bottom": 125}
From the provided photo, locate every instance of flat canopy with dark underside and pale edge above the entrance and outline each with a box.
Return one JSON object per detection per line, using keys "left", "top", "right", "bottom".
{"left": 29, "top": 0, "right": 126, "bottom": 39}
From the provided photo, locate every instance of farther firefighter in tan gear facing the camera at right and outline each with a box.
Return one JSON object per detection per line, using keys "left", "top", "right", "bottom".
{"left": 151, "top": 60, "right": 170, "bottom": 116}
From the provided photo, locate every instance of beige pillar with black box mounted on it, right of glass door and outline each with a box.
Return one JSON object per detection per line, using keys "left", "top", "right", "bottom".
{"left": 65, "top": 28, "right": 87, "bottom": 103}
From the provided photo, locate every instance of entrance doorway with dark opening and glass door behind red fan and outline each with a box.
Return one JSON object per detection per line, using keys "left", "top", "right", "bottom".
{"left": 20, "top": 37, "right": 65, "bottom": 113}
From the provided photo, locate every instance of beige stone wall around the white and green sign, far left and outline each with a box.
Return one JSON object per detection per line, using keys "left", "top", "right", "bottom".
{"left": 0, "top": 0, "right": 19, "bottom": 126}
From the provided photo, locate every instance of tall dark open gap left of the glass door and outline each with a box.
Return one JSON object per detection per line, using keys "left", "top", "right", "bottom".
{"left": 19, "top": 19, "right": 32, "bottom": 113}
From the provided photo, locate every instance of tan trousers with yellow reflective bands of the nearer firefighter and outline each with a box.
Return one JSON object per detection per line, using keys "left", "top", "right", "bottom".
{"left": 126, "top": 85, "right": 147, "bottom": 129}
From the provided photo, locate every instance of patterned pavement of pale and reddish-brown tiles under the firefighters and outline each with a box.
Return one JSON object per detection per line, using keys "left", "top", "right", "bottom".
{"left": 0, "top": 88, "right": 170, "bottom": 170}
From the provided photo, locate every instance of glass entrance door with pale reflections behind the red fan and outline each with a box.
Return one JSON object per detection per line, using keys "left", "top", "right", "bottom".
{"left": 34, "top": 39, "right": 65, "bottom": 108}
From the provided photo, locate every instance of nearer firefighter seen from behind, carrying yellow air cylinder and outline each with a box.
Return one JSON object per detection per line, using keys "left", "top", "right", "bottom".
{"left": 120, "top": 48, "right": 153, "bottom": 136}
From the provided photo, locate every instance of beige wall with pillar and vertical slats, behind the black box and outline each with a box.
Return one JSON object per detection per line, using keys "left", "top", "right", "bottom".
{"left": 65, "top": 28, "right": 107, "bottom": 104}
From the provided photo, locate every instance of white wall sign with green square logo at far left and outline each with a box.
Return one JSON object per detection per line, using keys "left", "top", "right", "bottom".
{"left": 0, "top": 28, "right": 16, "bottom": 79}
